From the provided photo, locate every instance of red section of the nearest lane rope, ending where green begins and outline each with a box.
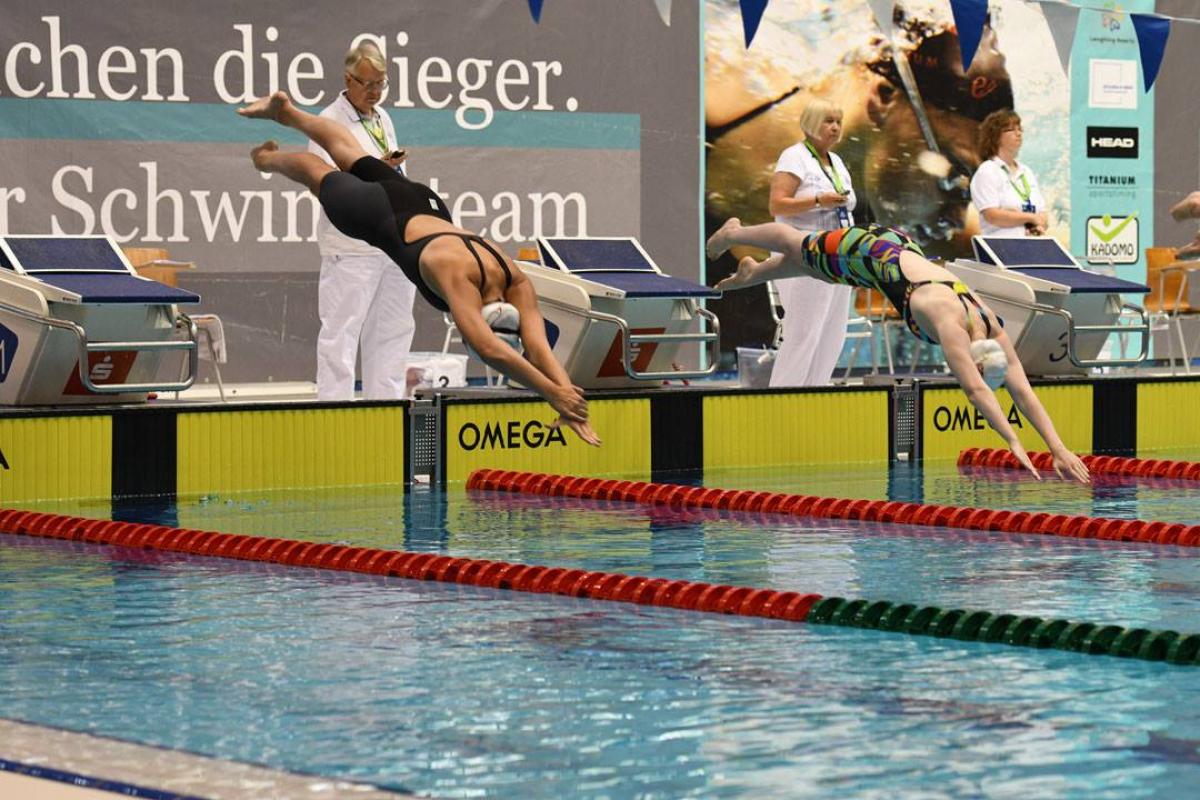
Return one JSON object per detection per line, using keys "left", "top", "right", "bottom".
{"left": 0, "top": 509, "right": 822, "bottom": 622}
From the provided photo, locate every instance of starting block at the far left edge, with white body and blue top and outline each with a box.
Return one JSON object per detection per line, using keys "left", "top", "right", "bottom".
{"left": 0, "top": 236, "right": 200, "bottom": 405}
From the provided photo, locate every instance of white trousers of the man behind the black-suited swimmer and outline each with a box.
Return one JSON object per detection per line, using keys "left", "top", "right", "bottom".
{"left": 317, "top": 254, "right": 416, "bottom": 401}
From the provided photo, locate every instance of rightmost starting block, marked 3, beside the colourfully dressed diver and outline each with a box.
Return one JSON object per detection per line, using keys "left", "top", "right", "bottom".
{"left": 946, "top": 236, "right": 1150, "bottom": 375}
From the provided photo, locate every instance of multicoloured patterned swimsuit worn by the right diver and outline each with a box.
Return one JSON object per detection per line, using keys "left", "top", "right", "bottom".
{"left": 804, "top": 225, "right": 991, "bottom": 344}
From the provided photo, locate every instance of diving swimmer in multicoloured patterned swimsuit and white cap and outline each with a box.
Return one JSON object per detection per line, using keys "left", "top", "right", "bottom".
{"left": 706, "top": 219, "right": 1090, "bottom": 482}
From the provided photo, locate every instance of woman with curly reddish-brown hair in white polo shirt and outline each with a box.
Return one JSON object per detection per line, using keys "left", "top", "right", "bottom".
{"left": 971, "top": 110, "right": 1048, "bottom": 236}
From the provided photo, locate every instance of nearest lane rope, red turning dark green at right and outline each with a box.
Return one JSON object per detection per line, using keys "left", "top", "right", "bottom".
{"left": 0, "top": 509, "right": 1200, "bottom": 666}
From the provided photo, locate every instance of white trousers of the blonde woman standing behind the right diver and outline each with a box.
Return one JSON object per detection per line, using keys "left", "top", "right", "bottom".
{"left": 770, "top": 278, "right": 853, "bottom": 386}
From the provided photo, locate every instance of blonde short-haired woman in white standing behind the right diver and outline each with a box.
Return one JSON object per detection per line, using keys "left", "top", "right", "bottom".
{"left": 768, "top": 97, "right": 857, "bottom": 386}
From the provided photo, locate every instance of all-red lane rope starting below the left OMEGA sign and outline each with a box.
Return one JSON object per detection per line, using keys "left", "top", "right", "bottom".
{"left": 467, "top": 469, "right": 1200, "bottom": 547}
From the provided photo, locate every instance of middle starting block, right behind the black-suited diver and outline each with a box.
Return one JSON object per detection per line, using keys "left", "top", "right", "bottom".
{"left": 517, "top": 237, "right": 720, "bottom": 389}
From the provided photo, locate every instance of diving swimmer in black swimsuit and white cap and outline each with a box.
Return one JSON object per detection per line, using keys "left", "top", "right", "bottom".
{"left": 238, "top": 91, "right": 600, "bottom": 445}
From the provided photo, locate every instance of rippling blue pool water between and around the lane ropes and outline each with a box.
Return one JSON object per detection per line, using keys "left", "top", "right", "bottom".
{"left": 0, "top": 467, "right": 1200, "bottom": 798}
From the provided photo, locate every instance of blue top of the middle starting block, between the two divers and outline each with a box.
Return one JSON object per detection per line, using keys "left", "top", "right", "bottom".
{"left": 538, "top": 236, "right": 721, "bottom": 300}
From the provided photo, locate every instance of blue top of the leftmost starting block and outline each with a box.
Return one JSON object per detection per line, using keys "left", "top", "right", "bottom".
{"left": 0, "top": 236, "right": 200, "bottom": 303}
